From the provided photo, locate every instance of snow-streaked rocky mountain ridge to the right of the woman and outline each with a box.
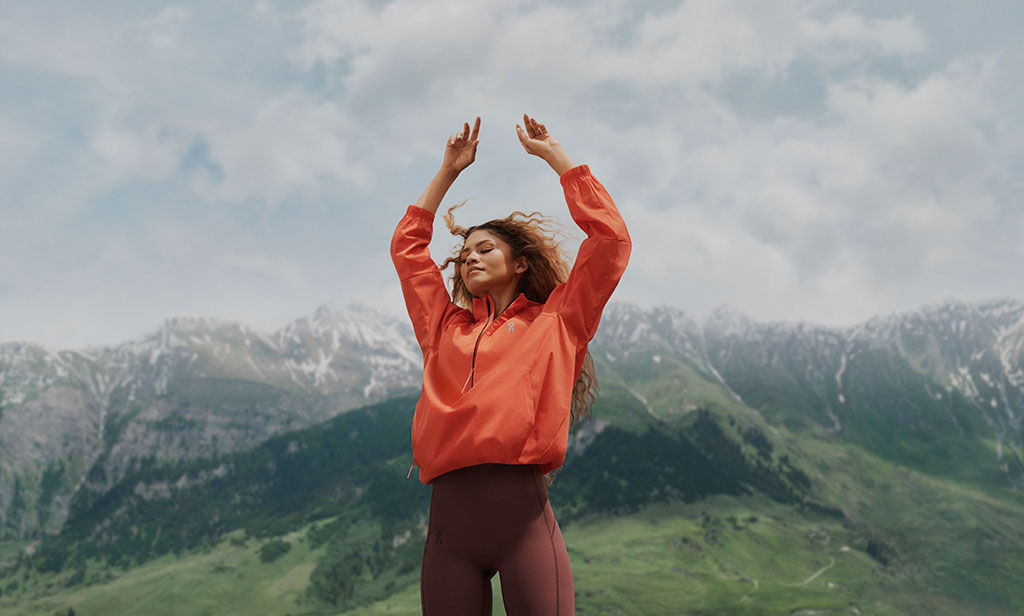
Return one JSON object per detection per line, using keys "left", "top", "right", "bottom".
{"left": 591, "top": 298, "right": 1024, "bottom": 487}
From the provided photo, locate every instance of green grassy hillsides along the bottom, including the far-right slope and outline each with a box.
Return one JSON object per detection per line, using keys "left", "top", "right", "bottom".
{"left": 0, "top": 464, "right": 1024, "bottom": 616}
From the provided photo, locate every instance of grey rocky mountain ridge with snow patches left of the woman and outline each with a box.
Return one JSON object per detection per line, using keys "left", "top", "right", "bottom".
{"left": 0, "top": 304, "right": 420, "bottom": 535}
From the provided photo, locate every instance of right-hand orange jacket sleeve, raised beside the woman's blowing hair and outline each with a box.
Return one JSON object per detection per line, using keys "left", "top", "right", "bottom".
{"left": 546, "top": 165, "right": 632, "bottom": 344}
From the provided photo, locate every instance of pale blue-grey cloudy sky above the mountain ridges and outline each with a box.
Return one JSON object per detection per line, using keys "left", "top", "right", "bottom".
{"left": 0, "top": 0, "right": 1024, "bottom": 348}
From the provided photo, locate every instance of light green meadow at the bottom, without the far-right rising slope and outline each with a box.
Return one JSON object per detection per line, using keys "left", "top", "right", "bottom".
{"left": 0, "top": 497, "right": 1019, "bottom": 616}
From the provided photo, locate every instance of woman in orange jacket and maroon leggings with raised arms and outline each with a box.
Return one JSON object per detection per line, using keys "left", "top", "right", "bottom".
{"left": 391, "top": 116, "right": 630, "bottom": 616}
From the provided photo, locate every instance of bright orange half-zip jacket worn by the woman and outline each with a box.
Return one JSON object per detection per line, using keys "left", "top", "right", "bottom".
{"left": 391, "top": 165, "right": 631, "bottom": 483}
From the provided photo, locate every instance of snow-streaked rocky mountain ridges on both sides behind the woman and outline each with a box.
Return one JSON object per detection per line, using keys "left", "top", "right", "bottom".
{"left": 0, "top": 299, "right": 1024, "bottom": 536}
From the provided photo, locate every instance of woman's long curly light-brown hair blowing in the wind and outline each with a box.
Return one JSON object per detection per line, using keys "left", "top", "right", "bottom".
{"left": 440, "top": 197, "right": 598, "bottom": 426}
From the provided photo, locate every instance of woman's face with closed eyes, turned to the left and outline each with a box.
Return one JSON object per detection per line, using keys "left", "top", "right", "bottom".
{"left": 459, "top": 229, "right": 526, "bottom": 297}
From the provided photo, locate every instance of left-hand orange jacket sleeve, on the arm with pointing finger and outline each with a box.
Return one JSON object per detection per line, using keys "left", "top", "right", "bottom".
{"left": 391, "top": 206, "right": 458, "bottom": 355}
